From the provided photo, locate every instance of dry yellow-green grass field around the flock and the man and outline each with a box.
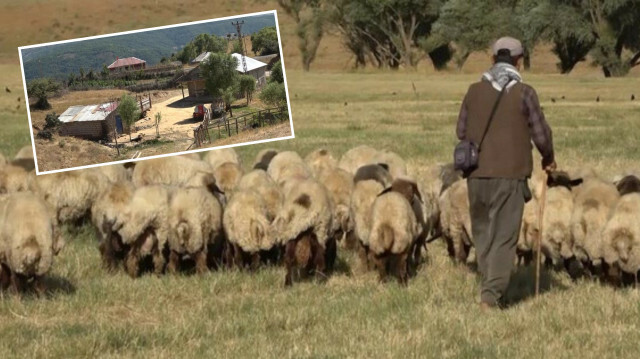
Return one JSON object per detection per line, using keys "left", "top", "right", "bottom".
{"left": 0, "top": 0, "right": 640, "bottom": 358}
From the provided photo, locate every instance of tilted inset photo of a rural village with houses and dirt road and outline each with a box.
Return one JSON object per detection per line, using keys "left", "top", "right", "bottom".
{"left": 18, "top": 10, "right": 294, "bottom": 174}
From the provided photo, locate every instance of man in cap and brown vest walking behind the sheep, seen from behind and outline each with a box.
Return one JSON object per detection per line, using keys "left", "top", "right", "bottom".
{"left": 456, "top": 37, "right": 556, "bottom": 309}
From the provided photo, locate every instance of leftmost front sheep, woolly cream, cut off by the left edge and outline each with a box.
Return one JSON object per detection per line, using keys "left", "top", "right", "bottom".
{"left": 0, "top": 192, "right": 64, "bottom": 294}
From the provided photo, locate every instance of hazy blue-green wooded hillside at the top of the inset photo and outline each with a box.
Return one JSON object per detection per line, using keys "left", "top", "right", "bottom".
{"left": 22, "top": 15, "right": 275, "bottom": 81}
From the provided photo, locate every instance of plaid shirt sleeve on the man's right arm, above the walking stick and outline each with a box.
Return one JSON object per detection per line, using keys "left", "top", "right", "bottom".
{"left": 522, "top": 86, "right": 554, "bottom": 166}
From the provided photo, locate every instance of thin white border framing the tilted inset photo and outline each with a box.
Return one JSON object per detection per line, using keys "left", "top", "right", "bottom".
{"left": 18, "top": 10, "right": 295, "bottom": 175}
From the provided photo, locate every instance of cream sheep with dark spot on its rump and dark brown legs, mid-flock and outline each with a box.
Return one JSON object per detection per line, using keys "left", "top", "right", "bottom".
{"left": 270, "top": 180, "right": 336, "bottom": 286}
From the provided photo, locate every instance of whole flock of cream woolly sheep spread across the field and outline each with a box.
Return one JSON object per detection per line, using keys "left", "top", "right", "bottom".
{"left": 0, "top": 146, "right": 640, "bottom": 293}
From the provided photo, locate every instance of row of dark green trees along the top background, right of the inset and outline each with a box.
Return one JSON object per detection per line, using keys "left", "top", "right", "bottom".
{"left": 278, "top": 0, "right": 640, "bottom": 77}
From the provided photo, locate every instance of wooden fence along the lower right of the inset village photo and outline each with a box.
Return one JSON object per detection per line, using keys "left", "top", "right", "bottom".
{"left": 189, "top": 107, "right": 289, "bottom": 148}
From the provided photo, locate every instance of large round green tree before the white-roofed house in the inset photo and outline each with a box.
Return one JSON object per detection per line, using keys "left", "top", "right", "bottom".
{"left": 200, "top": 53, "right": 238, "bottom": 116}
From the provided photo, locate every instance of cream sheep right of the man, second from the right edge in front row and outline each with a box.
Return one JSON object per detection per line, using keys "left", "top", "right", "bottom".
{"left": 571, "top": 177, "right": 620, "bottom": 272}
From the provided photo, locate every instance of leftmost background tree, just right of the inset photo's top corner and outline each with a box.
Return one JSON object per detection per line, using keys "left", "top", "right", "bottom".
{"left": 278, "top": 0, "right": 327, "bottom": 71}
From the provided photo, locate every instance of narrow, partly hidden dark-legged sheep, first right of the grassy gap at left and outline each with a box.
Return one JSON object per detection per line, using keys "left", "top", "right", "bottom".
{"left": 91, "top": 181, "right": 135, "bottom": 271}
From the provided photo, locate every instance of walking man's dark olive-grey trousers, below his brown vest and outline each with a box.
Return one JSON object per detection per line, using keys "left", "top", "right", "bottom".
{"left": 467, "top": 178, "right": 527, "bottom": 305}
